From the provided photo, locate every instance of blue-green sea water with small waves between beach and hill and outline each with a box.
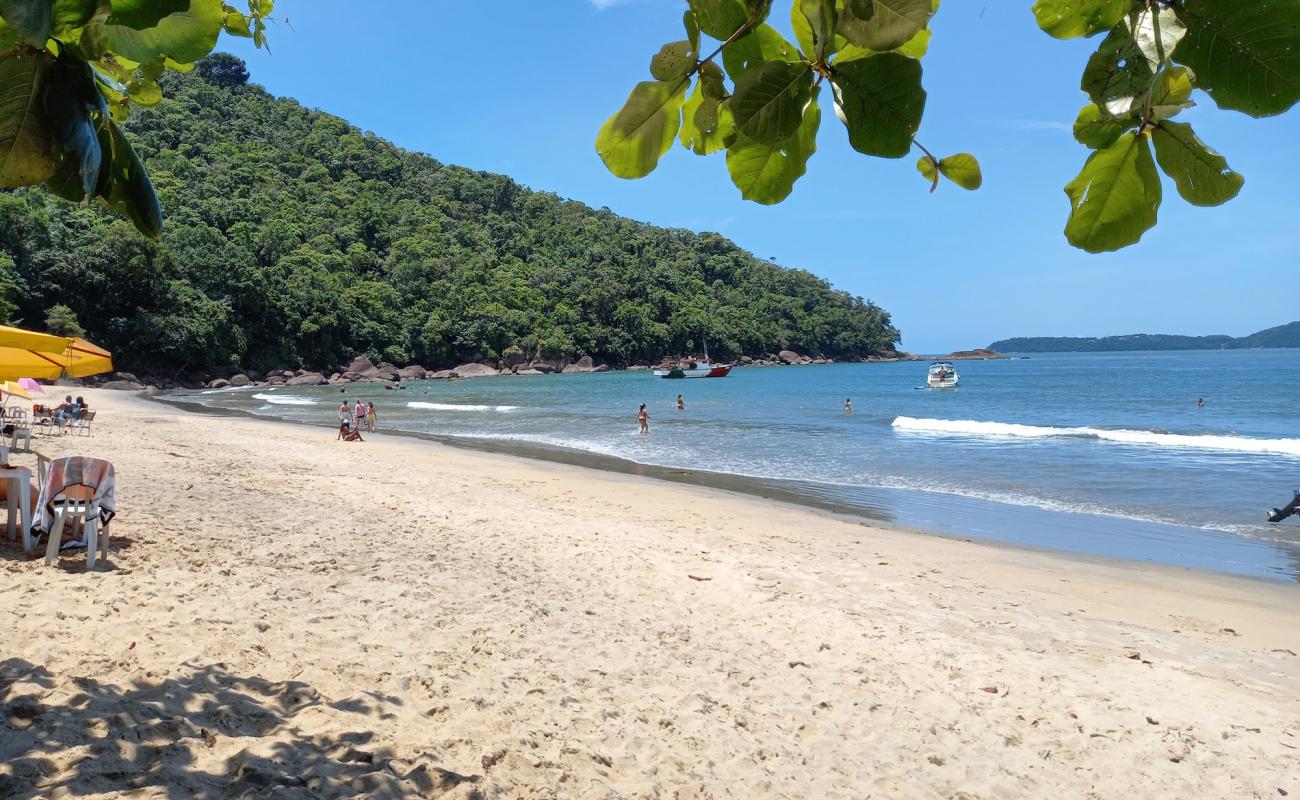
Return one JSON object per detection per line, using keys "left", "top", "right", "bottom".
{"left": 172, "top": 350, "right": 1300, "bottom": 580}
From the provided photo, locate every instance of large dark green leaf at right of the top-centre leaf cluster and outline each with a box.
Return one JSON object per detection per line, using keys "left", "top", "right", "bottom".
{"left": 831, "top": 52, "right": 930, "bottom": 159}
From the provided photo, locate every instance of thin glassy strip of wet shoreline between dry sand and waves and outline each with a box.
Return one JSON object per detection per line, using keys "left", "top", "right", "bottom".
{"left": 149, "top": 388, "right": 1300, "bottom": 584}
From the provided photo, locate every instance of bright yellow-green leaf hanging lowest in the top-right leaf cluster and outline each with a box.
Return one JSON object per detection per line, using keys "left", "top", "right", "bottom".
{"left": 1065, "top": 133, "right": 1160, "bottom": 252}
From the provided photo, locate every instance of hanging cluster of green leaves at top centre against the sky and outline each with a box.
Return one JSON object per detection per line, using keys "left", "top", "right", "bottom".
{"left": 595, "top": 0, "right": 979, "bottom": 204}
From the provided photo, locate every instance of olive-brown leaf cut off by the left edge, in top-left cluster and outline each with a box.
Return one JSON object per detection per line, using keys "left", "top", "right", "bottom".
{"left": 0, "top": 53, "right": 59, "bottom": 189}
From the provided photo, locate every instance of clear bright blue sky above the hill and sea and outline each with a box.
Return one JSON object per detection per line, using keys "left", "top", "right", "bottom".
{"left": 220, "top": 0, "right": 1300, "bottom": 353}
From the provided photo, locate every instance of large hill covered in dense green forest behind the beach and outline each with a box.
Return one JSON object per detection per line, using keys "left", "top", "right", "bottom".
{"left": 0, "top": 56, "right": 898, "bottom": 369}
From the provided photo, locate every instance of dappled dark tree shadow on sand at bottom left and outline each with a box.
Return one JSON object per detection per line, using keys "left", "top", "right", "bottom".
{"left": 0, "top": 658, "right": 481, "bottom": 800}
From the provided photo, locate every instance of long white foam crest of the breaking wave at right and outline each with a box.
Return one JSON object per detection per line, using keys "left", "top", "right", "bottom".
{"left": 893, "top": 416, "right": 1300, "bottom": 458}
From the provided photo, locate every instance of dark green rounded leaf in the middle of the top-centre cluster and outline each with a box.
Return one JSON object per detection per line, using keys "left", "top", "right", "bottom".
{"left": 731, "top": 61, "right": 813, "bottom": 144}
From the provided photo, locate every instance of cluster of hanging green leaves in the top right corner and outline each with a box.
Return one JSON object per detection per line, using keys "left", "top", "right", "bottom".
{"left": 1034, "top": 0, "right": 1300, "bottom": 252}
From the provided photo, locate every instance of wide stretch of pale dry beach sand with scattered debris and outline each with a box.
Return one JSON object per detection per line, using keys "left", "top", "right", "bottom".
{"left": 0, "top": 392, "right": 1300, "bottom": 799}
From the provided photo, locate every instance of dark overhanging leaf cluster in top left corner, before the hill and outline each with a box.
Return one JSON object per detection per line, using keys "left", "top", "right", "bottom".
{"left": 0, "top": 0, "right": 273, "bottom": 238}
